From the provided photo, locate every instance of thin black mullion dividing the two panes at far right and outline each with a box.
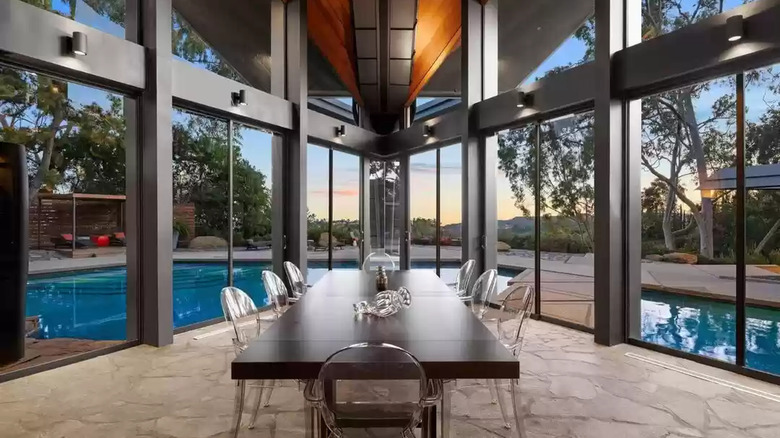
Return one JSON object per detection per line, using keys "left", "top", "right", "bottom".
{"left": 735, "top": 73, "right": 747, "bottom": 366}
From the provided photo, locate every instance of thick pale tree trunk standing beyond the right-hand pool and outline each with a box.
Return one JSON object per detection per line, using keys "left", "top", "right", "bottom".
{"left": 680, "top": 88, "right": 715, "bottom": 258}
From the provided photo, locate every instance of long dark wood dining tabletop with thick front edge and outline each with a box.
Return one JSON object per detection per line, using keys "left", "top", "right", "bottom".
{"left": 232, "top": 270, "right": 520, "bottom": 379}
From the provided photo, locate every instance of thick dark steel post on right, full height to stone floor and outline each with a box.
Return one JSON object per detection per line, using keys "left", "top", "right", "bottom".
{"left": 593, "top": 0, "right": 626, "bottom": 345}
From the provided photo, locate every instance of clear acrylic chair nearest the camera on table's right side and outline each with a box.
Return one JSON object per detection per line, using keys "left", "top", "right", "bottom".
{"left": 494, "top": 286, "right": 534, "bottom": 437}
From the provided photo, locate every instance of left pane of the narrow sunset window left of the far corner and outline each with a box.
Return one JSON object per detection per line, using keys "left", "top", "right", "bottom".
{"left": 306, "top": 144, "right": 330, "bottom": 284}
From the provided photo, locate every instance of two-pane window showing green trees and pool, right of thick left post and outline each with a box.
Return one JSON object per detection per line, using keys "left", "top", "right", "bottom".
{"left": 172, "top": 113, "right": 273, "bottom": 328}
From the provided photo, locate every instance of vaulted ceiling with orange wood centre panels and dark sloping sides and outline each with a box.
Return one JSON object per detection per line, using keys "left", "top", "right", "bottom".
{"left": 173, "top": 0, "right": 593, "bottom": 133}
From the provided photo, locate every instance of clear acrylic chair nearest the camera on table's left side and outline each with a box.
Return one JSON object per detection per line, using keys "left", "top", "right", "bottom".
{"left": 220, "top": 287, "right": 275, "bottom": 437}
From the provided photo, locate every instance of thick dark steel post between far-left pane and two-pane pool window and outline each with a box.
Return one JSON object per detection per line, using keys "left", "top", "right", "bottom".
{"left": 139, "top": 0, "right": 173, "bottom": 347}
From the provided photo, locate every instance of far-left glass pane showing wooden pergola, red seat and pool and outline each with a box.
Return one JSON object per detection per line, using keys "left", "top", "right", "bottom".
{"left": 0, "top": 66, "right": 138, "bottom": 373}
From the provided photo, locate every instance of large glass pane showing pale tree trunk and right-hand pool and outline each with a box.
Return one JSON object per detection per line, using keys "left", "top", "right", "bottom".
{"left": 635, "top": 78, "right": 737, "bottom": 362}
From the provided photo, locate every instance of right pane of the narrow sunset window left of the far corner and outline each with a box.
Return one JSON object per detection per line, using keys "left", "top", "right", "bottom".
{"left": 333, "top": 151, "right": 361, "bottom": 269}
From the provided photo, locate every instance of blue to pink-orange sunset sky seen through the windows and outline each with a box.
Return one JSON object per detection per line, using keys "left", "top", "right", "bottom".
{"left": 30, "top": 0, "right": 766, "bottom": 224}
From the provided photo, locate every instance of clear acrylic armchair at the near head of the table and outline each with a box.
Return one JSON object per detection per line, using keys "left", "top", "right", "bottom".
{"left": 304, "top": 343, "right": 441, "bottom": 438}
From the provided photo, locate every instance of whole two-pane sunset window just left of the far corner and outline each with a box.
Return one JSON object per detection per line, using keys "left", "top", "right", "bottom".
{"left": 306, "top": 144, "right": 361, "bottom": 284}
